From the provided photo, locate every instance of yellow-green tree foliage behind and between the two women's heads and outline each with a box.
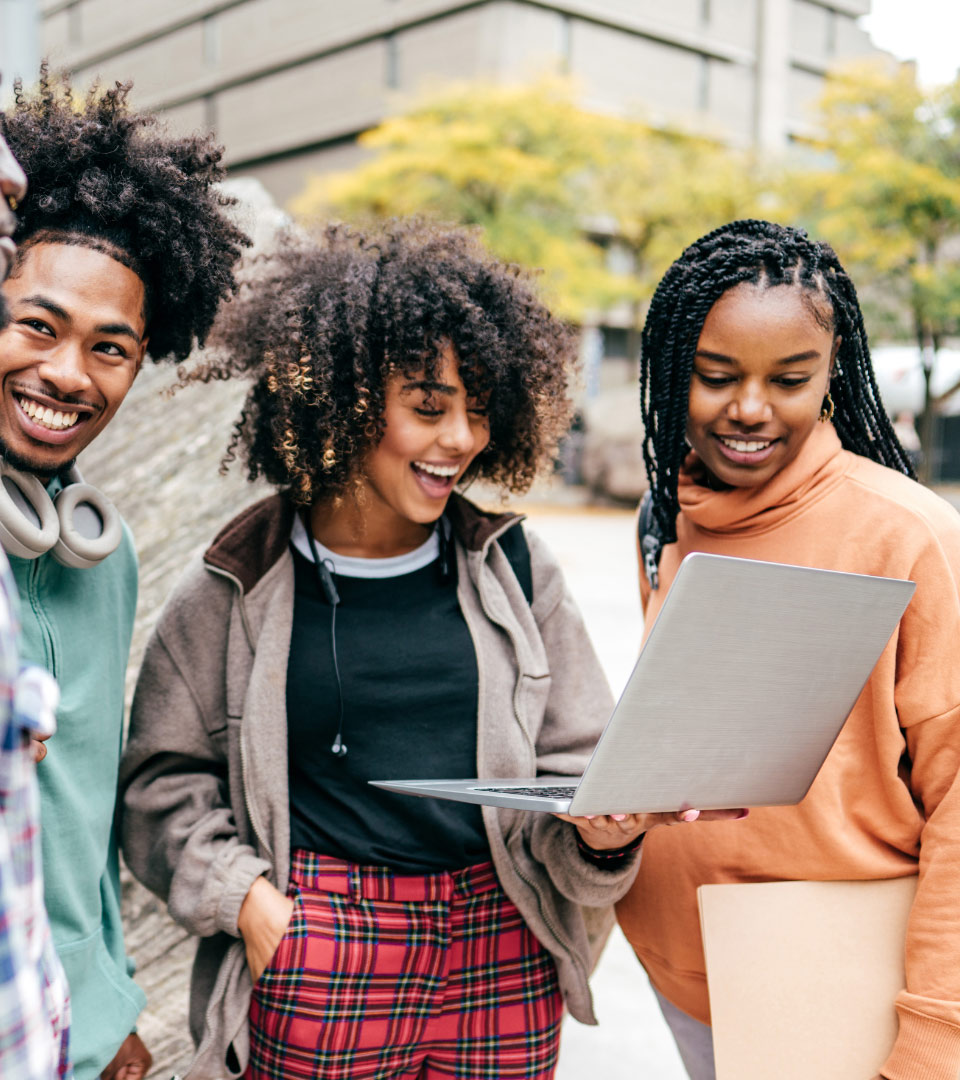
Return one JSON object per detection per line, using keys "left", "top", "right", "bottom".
{"left": 292, "top": 80, "right": 757, "bottom": 325}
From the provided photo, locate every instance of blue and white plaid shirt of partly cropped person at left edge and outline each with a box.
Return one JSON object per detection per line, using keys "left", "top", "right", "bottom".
{"left": 0, "top": 555, "right": 73, "bottom": 1080}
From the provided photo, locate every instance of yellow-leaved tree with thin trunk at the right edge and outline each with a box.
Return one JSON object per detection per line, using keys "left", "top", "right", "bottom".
{"left": 784, "top": 64, "right": 960, "bottom": 473}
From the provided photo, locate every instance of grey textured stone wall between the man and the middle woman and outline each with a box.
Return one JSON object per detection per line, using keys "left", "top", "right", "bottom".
{"left": 79, "top": 364, "right": 267, "bottom": 1080}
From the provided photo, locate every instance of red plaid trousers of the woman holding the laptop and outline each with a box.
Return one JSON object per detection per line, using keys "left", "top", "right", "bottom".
{"left": 246, "top": 850, "right": 563, "bottom": 1080}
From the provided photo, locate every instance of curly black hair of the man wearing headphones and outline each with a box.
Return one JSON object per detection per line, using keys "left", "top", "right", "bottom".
{"left": 0, "top": 64, "right": 249, "bottom": 361}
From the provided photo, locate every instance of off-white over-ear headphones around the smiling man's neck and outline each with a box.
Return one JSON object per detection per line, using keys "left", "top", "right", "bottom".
{"left": 0, "top": 460, "right": 123, "bottom": 570}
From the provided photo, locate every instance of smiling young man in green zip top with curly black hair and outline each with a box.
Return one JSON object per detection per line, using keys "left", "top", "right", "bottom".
{"left": 0, "top": 67, "right": 247, "bottom": 1080}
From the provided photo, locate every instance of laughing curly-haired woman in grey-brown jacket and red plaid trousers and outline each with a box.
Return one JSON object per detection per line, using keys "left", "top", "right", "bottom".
{"left": 122, "top": 224, "right": 725, "bottom": 1080}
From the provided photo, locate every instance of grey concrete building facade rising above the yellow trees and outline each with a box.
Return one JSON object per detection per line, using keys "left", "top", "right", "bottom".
{"left": 35, "top": 0, "right": 873, "bottom": 202}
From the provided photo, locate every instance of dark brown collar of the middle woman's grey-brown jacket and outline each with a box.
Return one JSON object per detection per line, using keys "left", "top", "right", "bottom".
{"left": 203, "top": 492, "right": 520, "bottom": 593}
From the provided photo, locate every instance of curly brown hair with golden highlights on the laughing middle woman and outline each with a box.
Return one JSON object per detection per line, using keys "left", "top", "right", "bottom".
{"left": 194, "top": 220, "right": 577, "bottom": 504}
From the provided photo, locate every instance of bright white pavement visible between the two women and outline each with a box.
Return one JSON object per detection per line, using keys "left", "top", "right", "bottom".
{"left": 517, "top": 505, "right": 686, "bottom": 1080}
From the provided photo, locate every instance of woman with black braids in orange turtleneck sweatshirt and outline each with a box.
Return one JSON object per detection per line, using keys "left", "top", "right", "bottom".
{"left": 618, "top": 221, "right": 960, "bottom": 1080}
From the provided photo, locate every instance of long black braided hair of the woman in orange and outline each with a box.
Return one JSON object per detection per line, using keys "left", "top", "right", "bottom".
{"left": 640, "top": 220, "right": 916, "bottom": 588}
